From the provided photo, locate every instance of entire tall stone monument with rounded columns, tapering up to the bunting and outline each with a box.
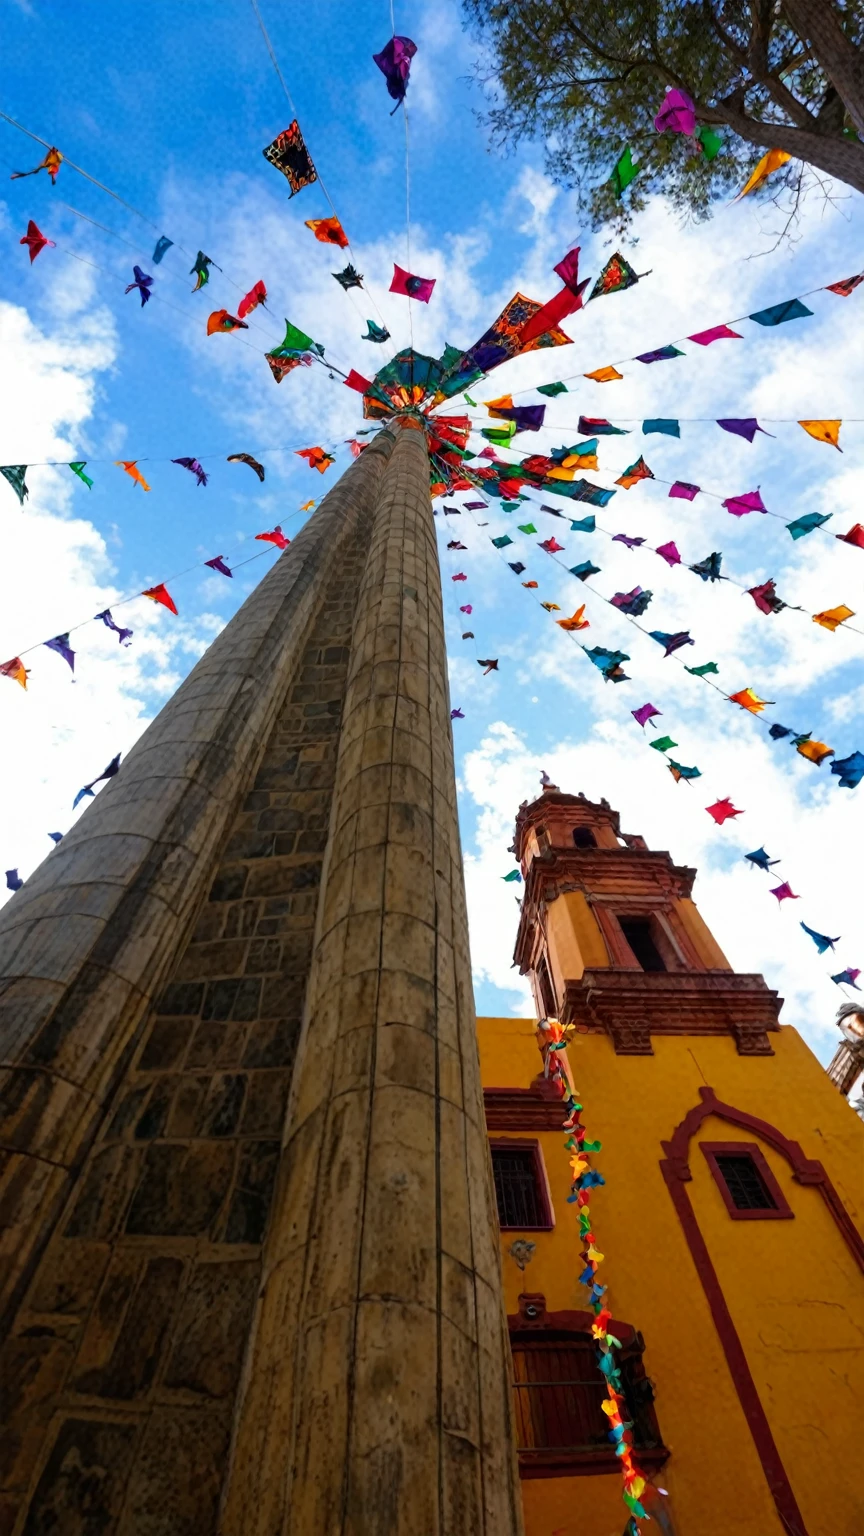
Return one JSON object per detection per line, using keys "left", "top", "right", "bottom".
{"left": 0, "top": 419, "right": 521, "bottom": 1536}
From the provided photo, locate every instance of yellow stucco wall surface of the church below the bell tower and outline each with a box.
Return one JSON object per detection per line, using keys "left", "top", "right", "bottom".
{"left": 478, "top": 1018, "right": 864, "bottom": 1536}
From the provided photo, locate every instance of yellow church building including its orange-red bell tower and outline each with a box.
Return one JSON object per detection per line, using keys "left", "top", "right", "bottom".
{"left": 478, "top": 785, "right": 864, "bottom": 1536}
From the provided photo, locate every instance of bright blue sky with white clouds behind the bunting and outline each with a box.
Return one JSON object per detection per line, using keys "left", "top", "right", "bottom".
{"left": 0, "top": 0, "right": 864, "bottom": 1055}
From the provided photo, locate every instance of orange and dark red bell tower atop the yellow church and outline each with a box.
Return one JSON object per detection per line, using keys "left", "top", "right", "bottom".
{"left": 513, "top": 783, "right": 781, "bottom": 1055}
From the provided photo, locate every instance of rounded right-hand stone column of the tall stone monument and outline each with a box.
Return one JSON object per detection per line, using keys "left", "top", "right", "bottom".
{"left": 220, "top": 429, "right": 521, "bottom": 1536}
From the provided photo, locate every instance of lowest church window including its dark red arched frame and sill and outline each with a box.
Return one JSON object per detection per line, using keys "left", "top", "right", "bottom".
{"left": 507, "top": 1295, "right": 669, "bottom": 1478}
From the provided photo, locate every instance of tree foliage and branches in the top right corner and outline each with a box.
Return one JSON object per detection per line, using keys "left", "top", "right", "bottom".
{"left": 463, "top": 0, "right": 864, "bottom": 227}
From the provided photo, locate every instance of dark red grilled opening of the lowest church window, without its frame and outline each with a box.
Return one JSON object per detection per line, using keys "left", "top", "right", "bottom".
{"left": 510, "top": 1333, "right": 661, "bottom": 1471}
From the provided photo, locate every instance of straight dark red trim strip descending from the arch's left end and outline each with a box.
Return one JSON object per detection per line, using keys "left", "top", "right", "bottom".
{"left": 660, "top": 1160, "right": 807, "bottom": 1536}
